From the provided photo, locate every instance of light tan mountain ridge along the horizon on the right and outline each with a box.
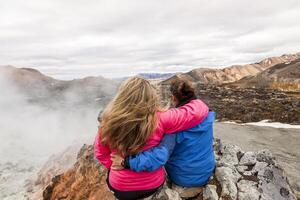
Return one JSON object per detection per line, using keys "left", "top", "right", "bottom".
{"left": 162, "top": 52, "right": 300, "bottom": 84}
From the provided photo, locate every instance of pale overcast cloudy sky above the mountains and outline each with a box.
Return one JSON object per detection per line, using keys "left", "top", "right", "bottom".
{"left": 0, "top": 0, "right": 300, "bottom": 79}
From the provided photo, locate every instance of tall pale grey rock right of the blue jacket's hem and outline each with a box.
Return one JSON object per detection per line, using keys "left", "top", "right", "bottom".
{"left": 215, "top": 167, "right": 241, "bottom": 200}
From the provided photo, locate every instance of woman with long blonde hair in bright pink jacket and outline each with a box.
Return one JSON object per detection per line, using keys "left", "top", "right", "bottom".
{"left": 94, "top": 77, "right": 208, "bottom": 200}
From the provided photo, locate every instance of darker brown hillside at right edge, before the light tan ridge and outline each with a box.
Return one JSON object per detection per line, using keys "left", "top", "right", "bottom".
{"left": 232, "top": 59, "right": 300, "bottom": 92}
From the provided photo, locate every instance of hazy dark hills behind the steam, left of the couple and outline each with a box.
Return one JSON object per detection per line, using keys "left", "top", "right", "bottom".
{"left": 0, "top": 66, "right": 118, "bottom": 106}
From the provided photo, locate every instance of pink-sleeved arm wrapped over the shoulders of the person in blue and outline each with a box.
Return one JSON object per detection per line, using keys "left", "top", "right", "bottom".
{"left": 160, "top": 99, "right": 209, "bottom": 133}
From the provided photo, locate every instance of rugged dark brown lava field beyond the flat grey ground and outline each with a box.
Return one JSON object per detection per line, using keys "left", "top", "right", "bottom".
{"left": 159, "top": 84, "right": 300, "bottom": 124}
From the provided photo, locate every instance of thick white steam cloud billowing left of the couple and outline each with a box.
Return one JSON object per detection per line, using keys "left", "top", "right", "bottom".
{"left": 0, "top": 75, "right": 107, "bottom": 199}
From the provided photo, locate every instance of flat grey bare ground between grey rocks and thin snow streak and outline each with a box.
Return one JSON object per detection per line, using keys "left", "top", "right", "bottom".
{"left": 214, "top": 123, "right": 300, "bottom": 197}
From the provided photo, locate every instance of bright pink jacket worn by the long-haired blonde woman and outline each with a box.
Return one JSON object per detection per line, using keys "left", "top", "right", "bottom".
{"left": 94, "top": 99, "right": 208, "bottom": 191}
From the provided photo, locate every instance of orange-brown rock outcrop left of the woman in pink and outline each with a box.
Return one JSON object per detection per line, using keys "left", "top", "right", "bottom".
{"left": 42, "top": 145, "right": 114, "bottom": 200}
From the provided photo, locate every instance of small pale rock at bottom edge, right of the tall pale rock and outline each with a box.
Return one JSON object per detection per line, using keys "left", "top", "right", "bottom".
{"left": 237, "top": 180, "right": 260, "bottom": 200}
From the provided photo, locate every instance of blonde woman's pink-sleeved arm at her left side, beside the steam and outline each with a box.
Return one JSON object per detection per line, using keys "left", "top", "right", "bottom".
{"left": 94, "top": 129, "right": 112, "bottom": 169}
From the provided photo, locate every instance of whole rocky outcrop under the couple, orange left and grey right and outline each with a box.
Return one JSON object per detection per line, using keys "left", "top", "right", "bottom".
{"left": 38, "top": 140, "right": 299, "bottom": 200}
